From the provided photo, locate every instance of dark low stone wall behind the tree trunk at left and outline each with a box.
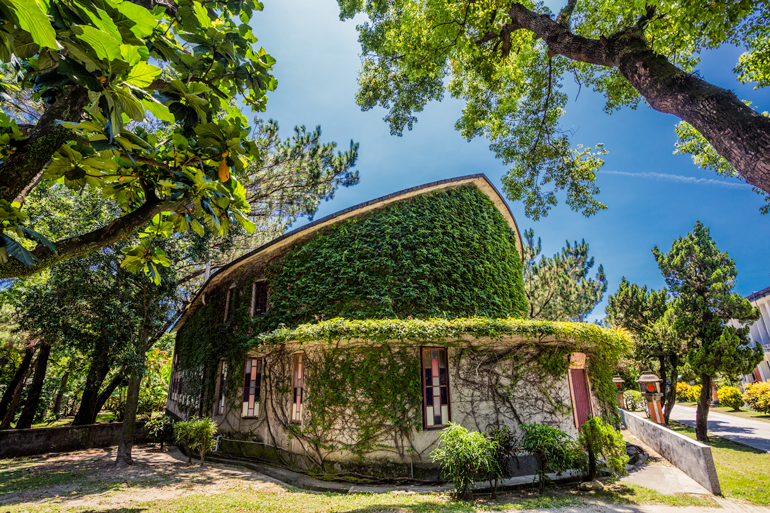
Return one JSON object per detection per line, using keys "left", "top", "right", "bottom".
{"left": 0, "top": 421, "right": 147, "bottom": 458}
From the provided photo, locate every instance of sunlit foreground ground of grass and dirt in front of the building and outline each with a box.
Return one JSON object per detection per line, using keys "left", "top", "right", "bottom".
{"left": 0, "top": 449, "right": 716, "bottom": 513}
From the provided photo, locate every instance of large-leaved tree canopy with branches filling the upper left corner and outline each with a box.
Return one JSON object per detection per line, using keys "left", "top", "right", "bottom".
{"left": 0, "top": 0, "right": 276, "bottom": 277}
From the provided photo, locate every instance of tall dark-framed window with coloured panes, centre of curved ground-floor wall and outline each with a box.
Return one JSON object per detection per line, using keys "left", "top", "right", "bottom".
{"left": 422, "top": 347, "right": 450, "bottom": 428}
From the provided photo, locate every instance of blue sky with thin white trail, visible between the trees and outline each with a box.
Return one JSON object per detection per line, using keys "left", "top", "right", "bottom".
{"left": 252, "top": 0, "right": 770, "bottom": 319}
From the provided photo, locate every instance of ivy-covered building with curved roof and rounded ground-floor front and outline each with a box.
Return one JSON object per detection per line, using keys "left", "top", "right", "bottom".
{"left": 168, "top": 175, "right": 626, "bottom": 477}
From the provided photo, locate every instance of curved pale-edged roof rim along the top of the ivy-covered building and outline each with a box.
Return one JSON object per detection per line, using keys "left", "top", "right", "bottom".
{"left": 171, "top": 173, "right": 524, "bottom": 332}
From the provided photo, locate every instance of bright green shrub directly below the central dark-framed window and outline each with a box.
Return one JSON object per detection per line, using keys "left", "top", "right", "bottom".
{"left": 430, "top": 422, "right": 500, "bottom": 499}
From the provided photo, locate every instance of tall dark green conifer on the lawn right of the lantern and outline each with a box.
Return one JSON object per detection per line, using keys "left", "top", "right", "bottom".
{"left": 652, "top": 221, "right": 763, "bottom": 442}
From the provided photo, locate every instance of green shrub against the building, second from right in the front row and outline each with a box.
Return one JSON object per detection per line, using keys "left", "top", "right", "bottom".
{"left": 521, "top": 424, "right": 586, "bottom": 493}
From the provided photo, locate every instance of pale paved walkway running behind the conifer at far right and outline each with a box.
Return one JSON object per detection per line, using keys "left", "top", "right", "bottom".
{"left": 671, "top": 405, "right": 770, "bottom": 452}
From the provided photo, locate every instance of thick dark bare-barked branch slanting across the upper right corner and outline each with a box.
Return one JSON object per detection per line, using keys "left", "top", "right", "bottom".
{"left": 492, "top": 3, "right": 770, "bottom": 193}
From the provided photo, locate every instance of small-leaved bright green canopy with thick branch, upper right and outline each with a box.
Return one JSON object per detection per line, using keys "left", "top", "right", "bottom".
{"left": 338, "top": 0, "right": 770, "bottom": 219}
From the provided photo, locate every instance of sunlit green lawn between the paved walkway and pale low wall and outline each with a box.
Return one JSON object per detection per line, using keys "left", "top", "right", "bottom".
{"left": 669, "top": 422, "right": 770, "bottom": 504}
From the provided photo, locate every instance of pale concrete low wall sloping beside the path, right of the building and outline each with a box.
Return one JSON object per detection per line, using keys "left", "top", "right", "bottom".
{"left": 620, "top": 410, "right": 722, "bottom": 494}
